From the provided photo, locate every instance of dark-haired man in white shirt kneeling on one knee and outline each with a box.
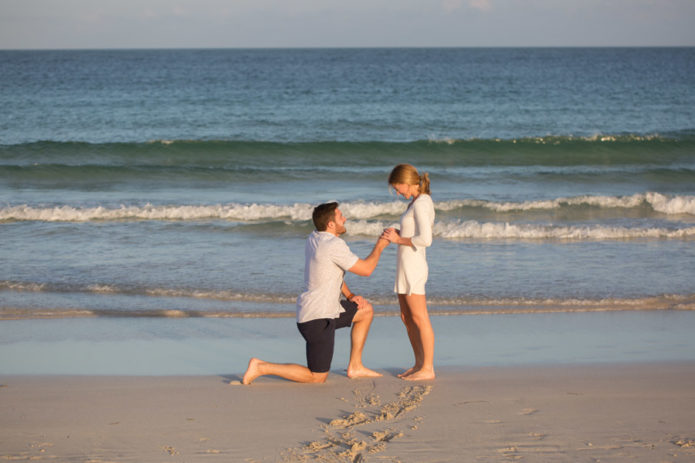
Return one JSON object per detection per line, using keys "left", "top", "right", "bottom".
{"left": 242, "top": 203, "right": 389, "bottom": 384}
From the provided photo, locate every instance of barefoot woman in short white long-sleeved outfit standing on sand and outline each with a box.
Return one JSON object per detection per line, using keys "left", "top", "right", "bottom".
{"left": 382, "top": 164, "right": 435, "bottom": 381}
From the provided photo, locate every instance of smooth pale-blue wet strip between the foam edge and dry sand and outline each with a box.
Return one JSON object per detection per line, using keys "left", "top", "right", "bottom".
{"left": 0, "top": 311, "right": 695, "bottom": 375}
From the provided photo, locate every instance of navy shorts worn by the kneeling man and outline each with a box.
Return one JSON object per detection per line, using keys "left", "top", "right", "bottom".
{"left": 297, "top": 300, "right": 357, "bottom": 373}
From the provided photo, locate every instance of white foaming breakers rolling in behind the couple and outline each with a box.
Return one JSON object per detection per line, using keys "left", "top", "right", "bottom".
{"left": 0, "top": 192, "right": 695, "bottom": 240}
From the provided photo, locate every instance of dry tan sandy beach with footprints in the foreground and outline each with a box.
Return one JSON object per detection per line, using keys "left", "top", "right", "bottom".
{"left": 0, "top": 363, "right": 695, "bottom": 463}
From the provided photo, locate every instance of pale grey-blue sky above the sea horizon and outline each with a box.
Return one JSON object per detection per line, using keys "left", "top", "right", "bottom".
{"left": 0, "top": 0, "right": 695, "bottom": 49}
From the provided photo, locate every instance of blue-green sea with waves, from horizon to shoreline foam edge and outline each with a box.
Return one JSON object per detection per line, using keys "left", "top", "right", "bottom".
{"left": 0, "top": 48, "right": 695, "bottom": 319}
